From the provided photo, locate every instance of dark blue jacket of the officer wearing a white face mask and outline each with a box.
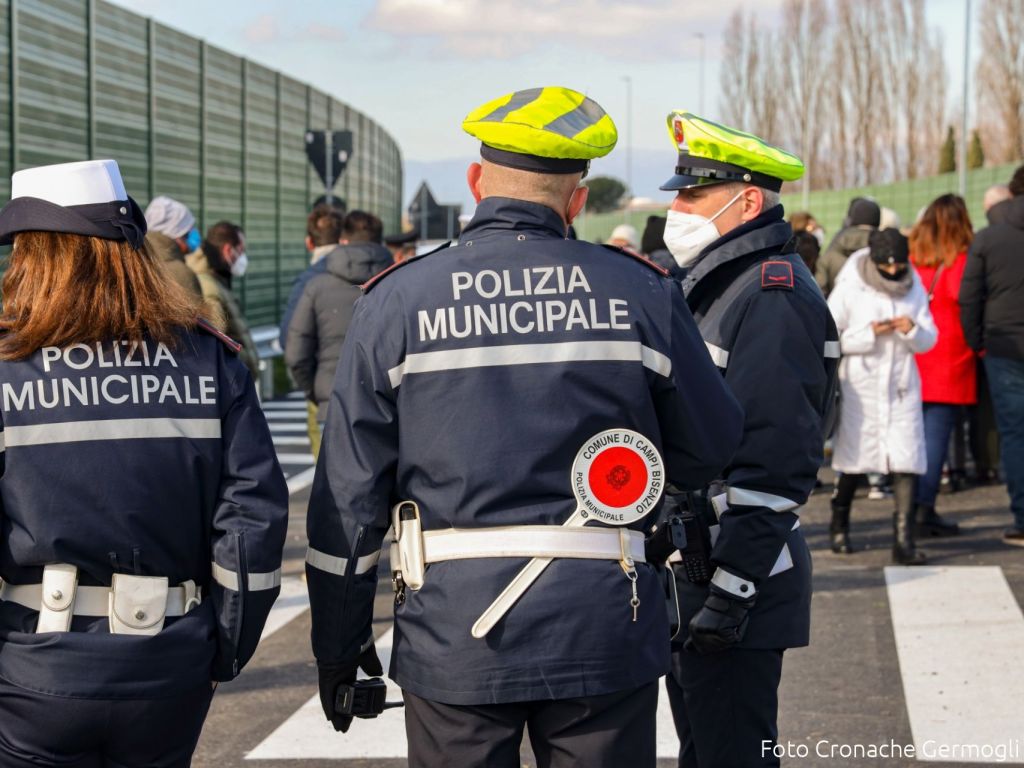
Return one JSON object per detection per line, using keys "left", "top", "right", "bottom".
{"left": 677, "top": 206, "right": 839, "bottom": 648}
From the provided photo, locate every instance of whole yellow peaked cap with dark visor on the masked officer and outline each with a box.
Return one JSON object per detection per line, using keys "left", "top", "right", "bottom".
{"left": 660, "top": 110, "right": 804, "bottom": 191}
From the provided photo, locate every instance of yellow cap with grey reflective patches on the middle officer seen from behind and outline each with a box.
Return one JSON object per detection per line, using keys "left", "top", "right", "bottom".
{"left": 462, "top": 87, "right": 618, "bottom": 173}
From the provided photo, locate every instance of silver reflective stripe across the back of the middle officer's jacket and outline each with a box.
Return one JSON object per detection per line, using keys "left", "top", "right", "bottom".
{"left": 388, "top": 341, "right": 672, "bottom": 387}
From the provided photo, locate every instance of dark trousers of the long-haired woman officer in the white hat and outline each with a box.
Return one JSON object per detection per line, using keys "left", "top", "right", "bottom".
{"left": 0, "top": 680, "right": 213, "bottom": 768}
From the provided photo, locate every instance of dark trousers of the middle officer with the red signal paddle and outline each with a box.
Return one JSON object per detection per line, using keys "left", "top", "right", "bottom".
{"left": 403, "top": 682, "right": 657, "bottom": 768}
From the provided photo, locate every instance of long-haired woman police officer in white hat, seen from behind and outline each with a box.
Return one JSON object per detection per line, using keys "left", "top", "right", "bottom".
{"left": 0, "top": 160, "right": 288, "bottom": 768}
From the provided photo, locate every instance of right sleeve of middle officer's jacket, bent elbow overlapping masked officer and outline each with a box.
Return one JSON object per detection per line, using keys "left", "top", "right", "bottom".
{"left": 654, "top": 281, "right": 743, "bottom": 489}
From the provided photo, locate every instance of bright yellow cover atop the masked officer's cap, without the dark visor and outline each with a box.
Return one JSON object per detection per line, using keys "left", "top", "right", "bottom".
{"left": 668, "top": 110, "right": 804, "bottom": 181}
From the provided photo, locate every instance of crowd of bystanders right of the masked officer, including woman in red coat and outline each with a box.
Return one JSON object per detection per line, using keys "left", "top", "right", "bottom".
{"left": 606, "top": 167, "right": 1024, "bottom": 564}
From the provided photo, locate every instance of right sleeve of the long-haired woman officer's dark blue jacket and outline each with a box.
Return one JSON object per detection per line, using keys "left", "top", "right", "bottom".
{"left": 210, "top": 354, "right": 288, "bottom": 680}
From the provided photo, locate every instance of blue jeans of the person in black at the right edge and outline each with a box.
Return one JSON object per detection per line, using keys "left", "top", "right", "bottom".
{"left": 985, "top": 354, "right": 1024, "bottom": 529}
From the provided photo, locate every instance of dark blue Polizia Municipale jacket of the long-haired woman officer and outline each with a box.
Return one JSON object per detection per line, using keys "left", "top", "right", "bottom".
{"left": 0, "top": 330, "right": 288, "bottom": 700}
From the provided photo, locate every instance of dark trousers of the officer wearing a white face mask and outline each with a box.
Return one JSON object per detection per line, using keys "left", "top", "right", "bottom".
{"left": 665, "top": 648, "right": 782, "bottom": 768}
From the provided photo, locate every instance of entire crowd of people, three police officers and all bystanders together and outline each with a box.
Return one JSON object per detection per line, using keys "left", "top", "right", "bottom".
{"left": 0, "top": 79, "right": 1024, "bottom": 768}
